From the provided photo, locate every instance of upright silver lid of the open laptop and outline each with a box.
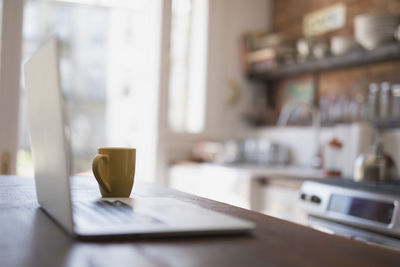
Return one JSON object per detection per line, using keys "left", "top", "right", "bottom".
{"left": 24, "top": 38, "right": 73, "bottom": 233}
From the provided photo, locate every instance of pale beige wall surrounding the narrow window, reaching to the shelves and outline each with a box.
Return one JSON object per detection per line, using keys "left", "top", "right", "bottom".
{"left": 157, "top": 0, "right": 272, "bottom": 183}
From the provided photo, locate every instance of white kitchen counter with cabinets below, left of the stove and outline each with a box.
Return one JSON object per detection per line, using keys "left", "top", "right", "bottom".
{"left": 169, "top": 161, "right": 324, "bottom": 224}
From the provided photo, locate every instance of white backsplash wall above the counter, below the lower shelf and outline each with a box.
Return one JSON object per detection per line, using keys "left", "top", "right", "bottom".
{"left": 252, "top": 123, "right": 400, "bottom": 177}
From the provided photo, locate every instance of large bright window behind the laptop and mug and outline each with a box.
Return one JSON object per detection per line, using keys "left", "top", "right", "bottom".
{"left": 17, "top": 0, "right": 160, "bottom": 182}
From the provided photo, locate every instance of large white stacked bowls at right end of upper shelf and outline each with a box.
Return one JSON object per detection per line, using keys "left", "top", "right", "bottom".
{"left": 354, "top": 14, "right": 400, "bottom": 50}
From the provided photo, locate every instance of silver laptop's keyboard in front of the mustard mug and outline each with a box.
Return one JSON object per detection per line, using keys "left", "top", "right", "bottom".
{"left": 72, "top": 200, "right": 163, "bottom": 225}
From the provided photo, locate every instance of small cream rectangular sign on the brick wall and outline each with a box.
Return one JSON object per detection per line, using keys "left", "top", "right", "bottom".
{"left": 303, "top": 4, "right": 346, "bottom": 36}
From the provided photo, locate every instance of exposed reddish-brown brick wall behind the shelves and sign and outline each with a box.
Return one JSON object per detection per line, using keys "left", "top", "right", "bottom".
{"left": 273, "top": 0, "right": 400, "bottom": 112}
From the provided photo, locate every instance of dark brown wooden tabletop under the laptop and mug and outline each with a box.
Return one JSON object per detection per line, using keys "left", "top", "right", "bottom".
{"left": 0, "top": 176, "right": 400, "bottom": 266}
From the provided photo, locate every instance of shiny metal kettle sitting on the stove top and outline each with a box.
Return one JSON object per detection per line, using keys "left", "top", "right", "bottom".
{"left": 353, "top": 134, "right": 398, "bottom": 182}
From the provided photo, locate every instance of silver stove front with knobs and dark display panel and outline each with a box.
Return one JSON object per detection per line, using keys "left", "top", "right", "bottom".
{"left": 299, "top": 179, "right": 400, "bottom": 250}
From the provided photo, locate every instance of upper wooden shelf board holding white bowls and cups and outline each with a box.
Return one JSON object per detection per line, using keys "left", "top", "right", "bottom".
{"left": 248, "top": 42, "right": 400, "bottom": 82}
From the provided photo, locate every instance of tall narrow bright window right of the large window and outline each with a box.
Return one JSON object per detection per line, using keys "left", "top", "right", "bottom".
{"left": 168, "top": 0, "right": 208, "bottom": 133}
